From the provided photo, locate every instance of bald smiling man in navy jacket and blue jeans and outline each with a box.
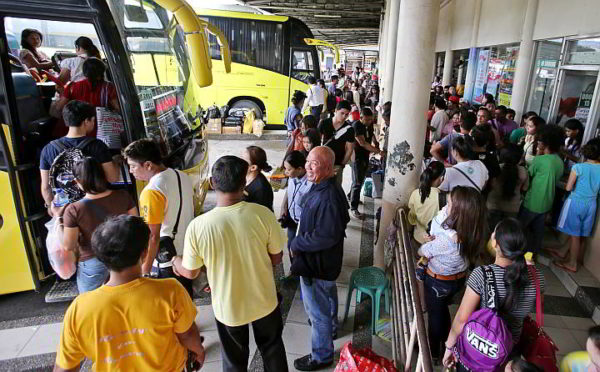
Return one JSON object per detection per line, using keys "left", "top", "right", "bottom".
{"left": 290, "top": 146, "right": 350, "bottom": 371}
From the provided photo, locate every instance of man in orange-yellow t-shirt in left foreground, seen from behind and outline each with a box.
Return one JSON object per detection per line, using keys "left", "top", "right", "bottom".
{"left": 54, "top": 215, "right": 204, "bottom": 372}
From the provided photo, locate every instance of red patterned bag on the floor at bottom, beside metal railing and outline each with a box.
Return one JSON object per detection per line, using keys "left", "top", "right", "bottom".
{"left": 334, "top": 342, "right": 398, "bottom": 372}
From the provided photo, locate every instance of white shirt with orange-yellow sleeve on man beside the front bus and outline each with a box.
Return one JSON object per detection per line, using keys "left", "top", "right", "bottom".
{"left": 140, "top": 168, "right": 194, "bottom": 254}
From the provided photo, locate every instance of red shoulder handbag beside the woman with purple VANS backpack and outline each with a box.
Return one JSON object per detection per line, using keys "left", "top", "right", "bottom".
{"left": 519, "top": 265, "right": 558, "bottom": 372}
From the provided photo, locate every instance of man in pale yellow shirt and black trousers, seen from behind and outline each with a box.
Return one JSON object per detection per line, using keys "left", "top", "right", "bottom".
{"left": 173, "top": 156, "right": 288, "bottom": 372}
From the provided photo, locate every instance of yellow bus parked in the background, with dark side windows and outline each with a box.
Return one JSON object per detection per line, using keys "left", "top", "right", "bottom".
{"left": 195, "top": 8, "right": 330, "bottom": 126}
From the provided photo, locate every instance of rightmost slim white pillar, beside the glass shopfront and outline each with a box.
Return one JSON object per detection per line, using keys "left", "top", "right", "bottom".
{"left": 510, "top": 0, "right": 539, "bottom": 118}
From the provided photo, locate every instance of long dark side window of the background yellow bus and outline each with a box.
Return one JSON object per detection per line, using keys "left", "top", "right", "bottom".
{"left": 201, "top": 16, "right": 283, "bottom": 73}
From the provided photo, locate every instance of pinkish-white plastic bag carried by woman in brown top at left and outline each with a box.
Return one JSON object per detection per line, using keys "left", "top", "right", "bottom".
{"left": 45, "top": 217, "right": 77, "bottom": 279}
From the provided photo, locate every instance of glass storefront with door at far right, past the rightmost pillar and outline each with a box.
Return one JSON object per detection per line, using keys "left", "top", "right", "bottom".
{"left": 525, "top": 37, "right": 600, "bottom": 142}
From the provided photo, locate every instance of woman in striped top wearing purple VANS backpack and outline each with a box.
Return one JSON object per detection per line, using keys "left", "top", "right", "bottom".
{"left": 443, "top": 218, "right": 544, "bottom": 371}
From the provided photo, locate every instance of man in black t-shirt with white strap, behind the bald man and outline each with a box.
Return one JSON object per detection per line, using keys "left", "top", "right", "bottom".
{"left": 318, "top": 101, "right": 354, "bottom": 186}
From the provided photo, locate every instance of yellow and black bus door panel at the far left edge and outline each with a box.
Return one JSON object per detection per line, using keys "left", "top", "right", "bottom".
{"left": 0, "top": 24, "right": 47, "bottom": 294}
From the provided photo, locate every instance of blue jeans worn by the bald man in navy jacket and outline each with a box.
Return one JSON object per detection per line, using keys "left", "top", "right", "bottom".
{"left": 300, "top": 277, "right": 338, "bottom": 363}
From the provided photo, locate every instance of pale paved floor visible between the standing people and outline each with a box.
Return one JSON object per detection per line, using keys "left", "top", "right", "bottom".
{"left": 0, "top": 140, "right": 594, "bottom": 372}
